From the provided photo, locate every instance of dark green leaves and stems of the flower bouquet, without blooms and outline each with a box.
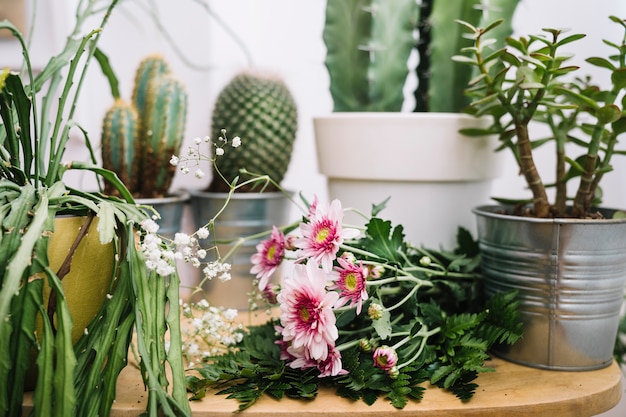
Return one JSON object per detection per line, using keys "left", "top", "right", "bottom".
{"left": 188, "top": 218, "right": 522, "bottom": 411}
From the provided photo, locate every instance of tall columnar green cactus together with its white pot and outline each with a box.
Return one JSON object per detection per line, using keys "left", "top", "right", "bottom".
{"left": 314, "top": 0, "right": 517, "bottom": 247}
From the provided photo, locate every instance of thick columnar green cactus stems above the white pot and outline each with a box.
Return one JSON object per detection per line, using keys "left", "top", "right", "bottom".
{"left": 323, "top": 0, "right": 518, "bottom": 112}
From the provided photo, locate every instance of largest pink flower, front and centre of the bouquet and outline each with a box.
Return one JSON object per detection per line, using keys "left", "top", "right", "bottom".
{"left": 277, "top": 260, "right": 339, "bottom": 361}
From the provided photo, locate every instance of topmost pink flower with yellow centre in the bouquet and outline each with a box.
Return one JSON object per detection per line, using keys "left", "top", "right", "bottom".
{"left": 295, "top": 200, "right": 359, "bottom": 273}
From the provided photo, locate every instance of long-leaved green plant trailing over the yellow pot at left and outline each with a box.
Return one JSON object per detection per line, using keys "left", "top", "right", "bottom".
{"left": 0, "top": 0, "right": 191, "bottom": 416}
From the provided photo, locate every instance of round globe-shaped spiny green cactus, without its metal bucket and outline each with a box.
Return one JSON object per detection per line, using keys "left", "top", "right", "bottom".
{"left": 208, "top": 73, "right": 298, "bottom": 192}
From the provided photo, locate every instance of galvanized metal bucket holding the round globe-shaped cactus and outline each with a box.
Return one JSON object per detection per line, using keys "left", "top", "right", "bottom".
{"left": 191, "top": 191, "right": 291, "bottom": 310}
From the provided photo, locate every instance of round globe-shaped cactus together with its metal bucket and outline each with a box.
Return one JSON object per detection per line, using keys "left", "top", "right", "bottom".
{"left": 191, "top": 71, "right": 298, "bottom": 309}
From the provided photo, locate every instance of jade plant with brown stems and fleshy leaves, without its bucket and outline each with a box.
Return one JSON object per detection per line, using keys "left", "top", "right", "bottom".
{"left": 454, "top": 16, "right": 626, "bottom": 218}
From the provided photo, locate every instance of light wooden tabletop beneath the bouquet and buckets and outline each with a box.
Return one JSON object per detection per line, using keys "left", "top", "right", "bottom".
{"left": 105, "top": 358, "right": 622, "bottom": 417}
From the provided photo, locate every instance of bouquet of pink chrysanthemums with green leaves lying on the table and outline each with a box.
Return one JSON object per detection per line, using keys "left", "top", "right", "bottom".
{"left": 151, "top": 131, "right": 521, "bottom": 410}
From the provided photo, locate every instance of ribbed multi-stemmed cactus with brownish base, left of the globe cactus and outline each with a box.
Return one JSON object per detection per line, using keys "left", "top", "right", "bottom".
{"left": 102, "top": 55, "right": 187, "bottom": 198}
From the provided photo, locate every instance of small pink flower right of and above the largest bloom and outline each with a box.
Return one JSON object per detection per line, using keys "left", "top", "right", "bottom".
{"left": 329, "top": 256, "right": 369, "bottom": 315}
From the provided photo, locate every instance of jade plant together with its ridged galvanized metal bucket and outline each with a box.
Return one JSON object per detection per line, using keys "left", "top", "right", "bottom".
{"left": 455, "top": 16, "right": 626, "bottom": 370}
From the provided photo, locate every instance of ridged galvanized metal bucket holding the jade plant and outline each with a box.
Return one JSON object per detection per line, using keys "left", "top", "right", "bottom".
{"left": 473, "top": 206, "right": 626, "bottom": 371}
